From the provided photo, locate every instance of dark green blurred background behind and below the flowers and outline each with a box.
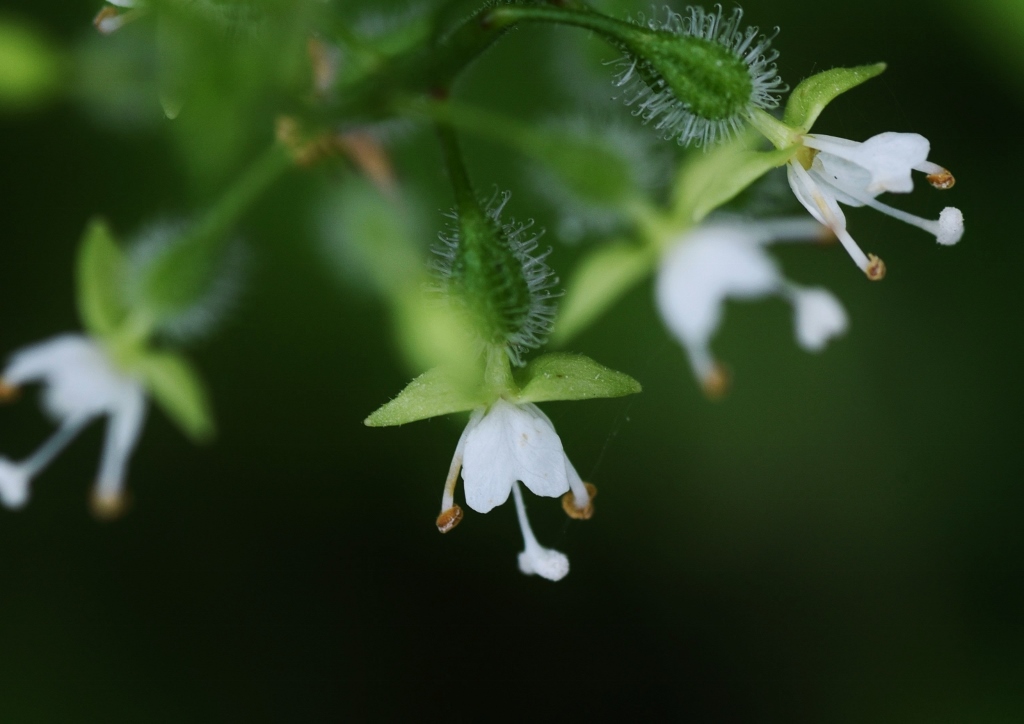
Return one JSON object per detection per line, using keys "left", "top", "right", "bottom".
{"left": 0, "top": 0, "right": 1024, "bottom": 723}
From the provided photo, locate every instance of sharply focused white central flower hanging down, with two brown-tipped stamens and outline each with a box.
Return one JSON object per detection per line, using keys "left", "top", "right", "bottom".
{"left": 437, "top": 399, "right": 596, "bottom": 581}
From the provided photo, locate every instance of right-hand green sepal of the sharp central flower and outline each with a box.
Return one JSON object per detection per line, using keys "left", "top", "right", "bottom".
{"left": 516, "top": 352, "right": 641, "bottom": 402}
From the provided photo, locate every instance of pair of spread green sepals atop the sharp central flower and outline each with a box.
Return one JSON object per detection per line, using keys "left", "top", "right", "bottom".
{"left": 364, "top": 353, "right": 641, "bottom": 427}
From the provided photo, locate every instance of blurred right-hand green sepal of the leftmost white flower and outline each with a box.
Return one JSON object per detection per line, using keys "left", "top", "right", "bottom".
{"left": 132, "top": 352, "right": 215, "bottom": 442}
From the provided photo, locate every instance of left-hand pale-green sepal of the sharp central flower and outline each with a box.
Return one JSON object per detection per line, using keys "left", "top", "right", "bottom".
{"left": 362, "top": 367, "right": 494, "bottom": 427}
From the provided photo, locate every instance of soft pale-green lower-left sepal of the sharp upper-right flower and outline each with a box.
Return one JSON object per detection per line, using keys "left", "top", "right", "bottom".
{"left": 673, "top": 133, "right": 798, "bottom": 225}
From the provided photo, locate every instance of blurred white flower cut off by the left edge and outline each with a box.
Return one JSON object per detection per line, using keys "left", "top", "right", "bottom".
{"left": 0, "top": 335, "right": 145, "bottom": 515}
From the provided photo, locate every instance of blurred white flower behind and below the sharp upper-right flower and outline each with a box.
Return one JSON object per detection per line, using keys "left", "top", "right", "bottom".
{"left": 655, "top": 219, "right": 847, "bottom": 395}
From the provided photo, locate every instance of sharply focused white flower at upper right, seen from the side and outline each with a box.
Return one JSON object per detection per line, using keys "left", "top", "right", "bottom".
{"left": 788, "top": 133, "right": 964, "bottom": 280}
